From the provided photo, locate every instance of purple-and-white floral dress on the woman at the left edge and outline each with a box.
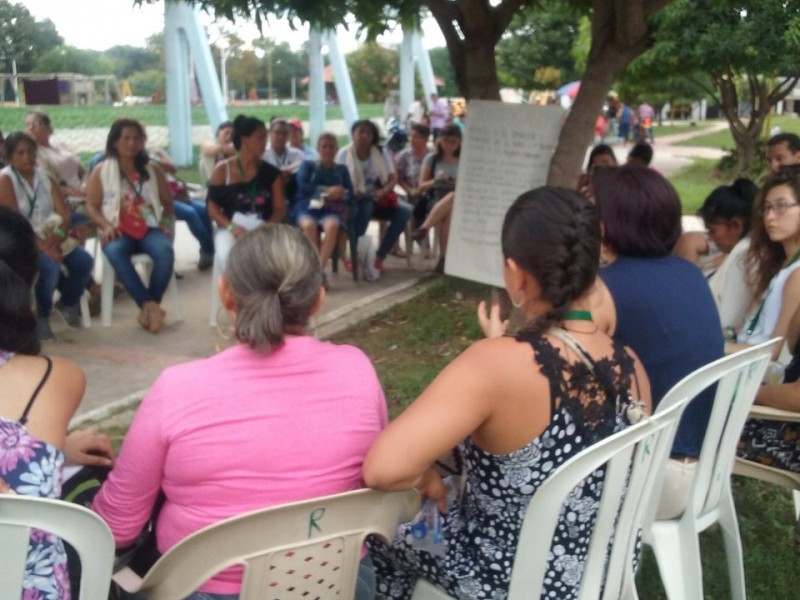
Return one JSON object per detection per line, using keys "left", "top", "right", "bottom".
{"left": 0, "top": 350, "right": 71, "bottom": 600}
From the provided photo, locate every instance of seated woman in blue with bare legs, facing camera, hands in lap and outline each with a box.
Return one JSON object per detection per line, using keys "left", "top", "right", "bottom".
{"left": 292, "top": 133, "right": 353, "bottom": 287}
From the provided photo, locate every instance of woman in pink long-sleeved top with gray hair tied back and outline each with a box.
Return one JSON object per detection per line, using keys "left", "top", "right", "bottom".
{"left": 93, "top": 224, "right": 386, "bottom": 599}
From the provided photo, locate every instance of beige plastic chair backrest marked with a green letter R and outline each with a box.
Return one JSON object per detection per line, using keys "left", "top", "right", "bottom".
{"left": 141, "top": 489, "right": 419, "bottom": 600}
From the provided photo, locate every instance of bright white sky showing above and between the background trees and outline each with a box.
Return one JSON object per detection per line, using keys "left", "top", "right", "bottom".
{"left": 21, "top": 0, "right": 445, "bottom": 53}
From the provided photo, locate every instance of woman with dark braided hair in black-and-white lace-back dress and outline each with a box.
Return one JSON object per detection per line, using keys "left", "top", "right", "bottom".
{"left": 364, "top": 187, "right": 650, "bottom": 599}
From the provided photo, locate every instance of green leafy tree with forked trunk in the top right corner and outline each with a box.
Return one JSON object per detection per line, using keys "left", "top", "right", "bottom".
{"left": 631, "top": 0, "right": 800, "bottom": 174}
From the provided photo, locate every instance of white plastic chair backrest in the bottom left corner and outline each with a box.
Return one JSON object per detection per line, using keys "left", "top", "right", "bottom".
{"left": 0, "top": 494, "right": 114, "bottom": 598}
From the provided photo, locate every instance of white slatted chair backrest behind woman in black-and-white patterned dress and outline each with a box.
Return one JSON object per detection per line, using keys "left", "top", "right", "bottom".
{"left": 508, "top": 398, "right": 684, "bottom": 600}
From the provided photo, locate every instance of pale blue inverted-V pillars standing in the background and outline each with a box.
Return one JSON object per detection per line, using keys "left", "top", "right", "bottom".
{"left": 164, "top": 0, "right": 436, "bottom": 166}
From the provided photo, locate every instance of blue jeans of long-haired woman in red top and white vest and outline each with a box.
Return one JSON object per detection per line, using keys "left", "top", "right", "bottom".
{"left": 103, "top": 227, "right": 175, "bottom": 306}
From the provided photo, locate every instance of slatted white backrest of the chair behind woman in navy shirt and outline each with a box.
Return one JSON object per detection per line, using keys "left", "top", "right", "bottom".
{"left": 656, "top": 338, "right": 783, "bottom": 518}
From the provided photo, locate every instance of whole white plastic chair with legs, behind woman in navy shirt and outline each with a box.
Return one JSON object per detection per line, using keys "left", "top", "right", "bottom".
{"left": 645, "top": 338, "right": 783, "bottom": 600}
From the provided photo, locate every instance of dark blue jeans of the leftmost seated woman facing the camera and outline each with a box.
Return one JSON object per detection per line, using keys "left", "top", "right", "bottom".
{"left": 34, "top": 246, "right": 94, "bottom": 319}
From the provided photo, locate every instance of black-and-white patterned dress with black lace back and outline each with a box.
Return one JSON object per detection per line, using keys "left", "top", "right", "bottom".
{"left": 369, "top": 335, "right": 634, "bottom": 600}
